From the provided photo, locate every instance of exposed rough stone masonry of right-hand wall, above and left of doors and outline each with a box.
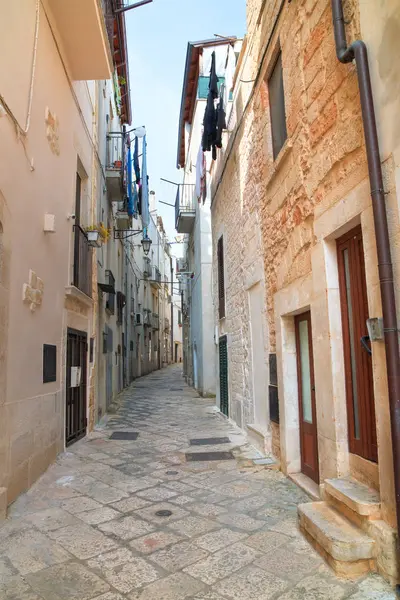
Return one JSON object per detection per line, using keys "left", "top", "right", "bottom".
{"left": 212, "top": 0, "right": 367, "bottom": 452}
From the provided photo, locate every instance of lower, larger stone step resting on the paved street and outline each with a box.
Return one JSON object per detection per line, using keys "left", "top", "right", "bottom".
{"left": 298, "top": 502, "right": 376, "bottom": 578}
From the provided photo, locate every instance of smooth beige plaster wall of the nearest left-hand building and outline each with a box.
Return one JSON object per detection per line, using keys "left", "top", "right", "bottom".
{"left": 0, "top": 0, "right": 96, "bottom": 502}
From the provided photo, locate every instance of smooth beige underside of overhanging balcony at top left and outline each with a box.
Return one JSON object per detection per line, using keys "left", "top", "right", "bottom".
{"left": 48, "top": 0, "right": 114, "bottom": 80}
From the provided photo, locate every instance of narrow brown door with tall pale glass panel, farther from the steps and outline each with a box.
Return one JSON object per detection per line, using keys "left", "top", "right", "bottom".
{"left": 295, "top": 312, "right": 319, "bottom": 483}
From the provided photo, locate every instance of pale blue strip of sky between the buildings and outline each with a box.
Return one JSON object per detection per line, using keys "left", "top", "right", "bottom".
{"left": 125, "top": 0, "right": 246, "bottom": 247}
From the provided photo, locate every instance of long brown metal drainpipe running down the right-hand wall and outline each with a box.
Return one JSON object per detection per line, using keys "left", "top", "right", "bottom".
{"left": 331, "top": 0, "right": 400, "bottom": 543}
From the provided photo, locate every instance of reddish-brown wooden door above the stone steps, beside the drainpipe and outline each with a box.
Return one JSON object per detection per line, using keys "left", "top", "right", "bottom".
{"left": 337, "top": 226, "right": 378, "bottom": 462}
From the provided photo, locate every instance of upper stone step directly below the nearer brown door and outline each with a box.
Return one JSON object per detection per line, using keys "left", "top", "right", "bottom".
{"left": 325, "top": 477, "right": 381, "bottom": 526}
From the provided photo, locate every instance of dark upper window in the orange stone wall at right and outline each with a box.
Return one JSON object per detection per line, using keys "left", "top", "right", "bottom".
{"left": 268, "top": 52, "right": 287, "bottom": 160}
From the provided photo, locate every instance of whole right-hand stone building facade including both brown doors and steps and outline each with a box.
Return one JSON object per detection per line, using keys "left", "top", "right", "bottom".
{"left": 211, "top": 0, "right": 400, "bottom": 581}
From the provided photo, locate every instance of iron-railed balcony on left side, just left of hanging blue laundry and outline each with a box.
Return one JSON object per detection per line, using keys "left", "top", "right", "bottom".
{"left": 106, "top": 133, "right": 126, "bottom": 202}
